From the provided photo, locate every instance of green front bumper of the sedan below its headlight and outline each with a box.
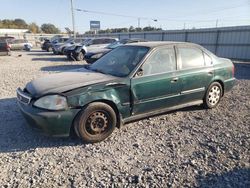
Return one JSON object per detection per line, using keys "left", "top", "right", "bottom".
{"left": 18, "top": 101, "right": 79, "bottom": 137}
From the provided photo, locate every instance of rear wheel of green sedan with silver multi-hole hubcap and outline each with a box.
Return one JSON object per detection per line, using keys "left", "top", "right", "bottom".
{"left": 203, "top": 82, "right": 223, "bottom": 108}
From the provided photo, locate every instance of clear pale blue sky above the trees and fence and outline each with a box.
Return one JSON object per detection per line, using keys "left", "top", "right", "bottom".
{"left": 0, "top": 0, "right": 250, "bottom": 33}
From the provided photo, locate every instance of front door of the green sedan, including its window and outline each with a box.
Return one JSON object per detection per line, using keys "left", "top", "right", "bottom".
{"left": 131, "top": 46, "right": 180, "bottom": 115}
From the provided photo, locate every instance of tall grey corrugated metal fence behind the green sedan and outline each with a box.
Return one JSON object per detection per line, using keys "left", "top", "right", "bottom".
{"left": 84, "top": 26, "right": 250, "bottom": 60}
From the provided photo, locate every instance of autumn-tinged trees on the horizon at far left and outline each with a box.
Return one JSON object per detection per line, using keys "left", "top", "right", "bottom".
{"left": 0, "top": 18, "right": 61, "bottom": 34}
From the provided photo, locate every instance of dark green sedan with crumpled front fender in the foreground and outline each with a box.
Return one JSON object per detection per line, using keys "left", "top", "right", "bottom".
{"left": 17, "top": 42, "right": 235, "bottom": 143}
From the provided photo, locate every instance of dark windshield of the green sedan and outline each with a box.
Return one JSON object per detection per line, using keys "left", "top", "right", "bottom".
{"left": 88, "top": 46, "right": 149, "bottom": 77}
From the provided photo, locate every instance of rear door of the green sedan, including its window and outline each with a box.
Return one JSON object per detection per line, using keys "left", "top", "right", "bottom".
{"left": 176, "top": 45, "right": 214, "bottom": 103}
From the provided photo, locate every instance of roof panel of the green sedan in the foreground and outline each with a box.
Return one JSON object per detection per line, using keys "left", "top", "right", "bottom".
{"left": 125, "top": 41, "right": 195, "bottom": 48}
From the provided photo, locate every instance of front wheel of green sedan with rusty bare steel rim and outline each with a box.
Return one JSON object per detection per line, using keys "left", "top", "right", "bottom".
{"left": 74, "top": 102, "right": 117, "bottom": 143}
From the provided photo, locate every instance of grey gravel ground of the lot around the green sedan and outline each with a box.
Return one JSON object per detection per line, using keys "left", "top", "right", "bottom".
{"left": 0, "top": 51, "right": 250, "bottom": 188}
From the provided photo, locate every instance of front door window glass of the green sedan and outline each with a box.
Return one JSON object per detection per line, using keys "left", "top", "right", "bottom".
{"left": 141, "top": 48, "right": 176, "bottom": 76}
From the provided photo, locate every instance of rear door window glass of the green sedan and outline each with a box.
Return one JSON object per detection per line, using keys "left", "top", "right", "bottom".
{"left": 178, "top": 47, "right": 204, "bottom": 69}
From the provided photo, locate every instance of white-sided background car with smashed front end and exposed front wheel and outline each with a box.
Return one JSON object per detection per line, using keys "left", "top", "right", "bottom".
{"left": 64, "top": 37, "right": 118, "bottom": 61}
